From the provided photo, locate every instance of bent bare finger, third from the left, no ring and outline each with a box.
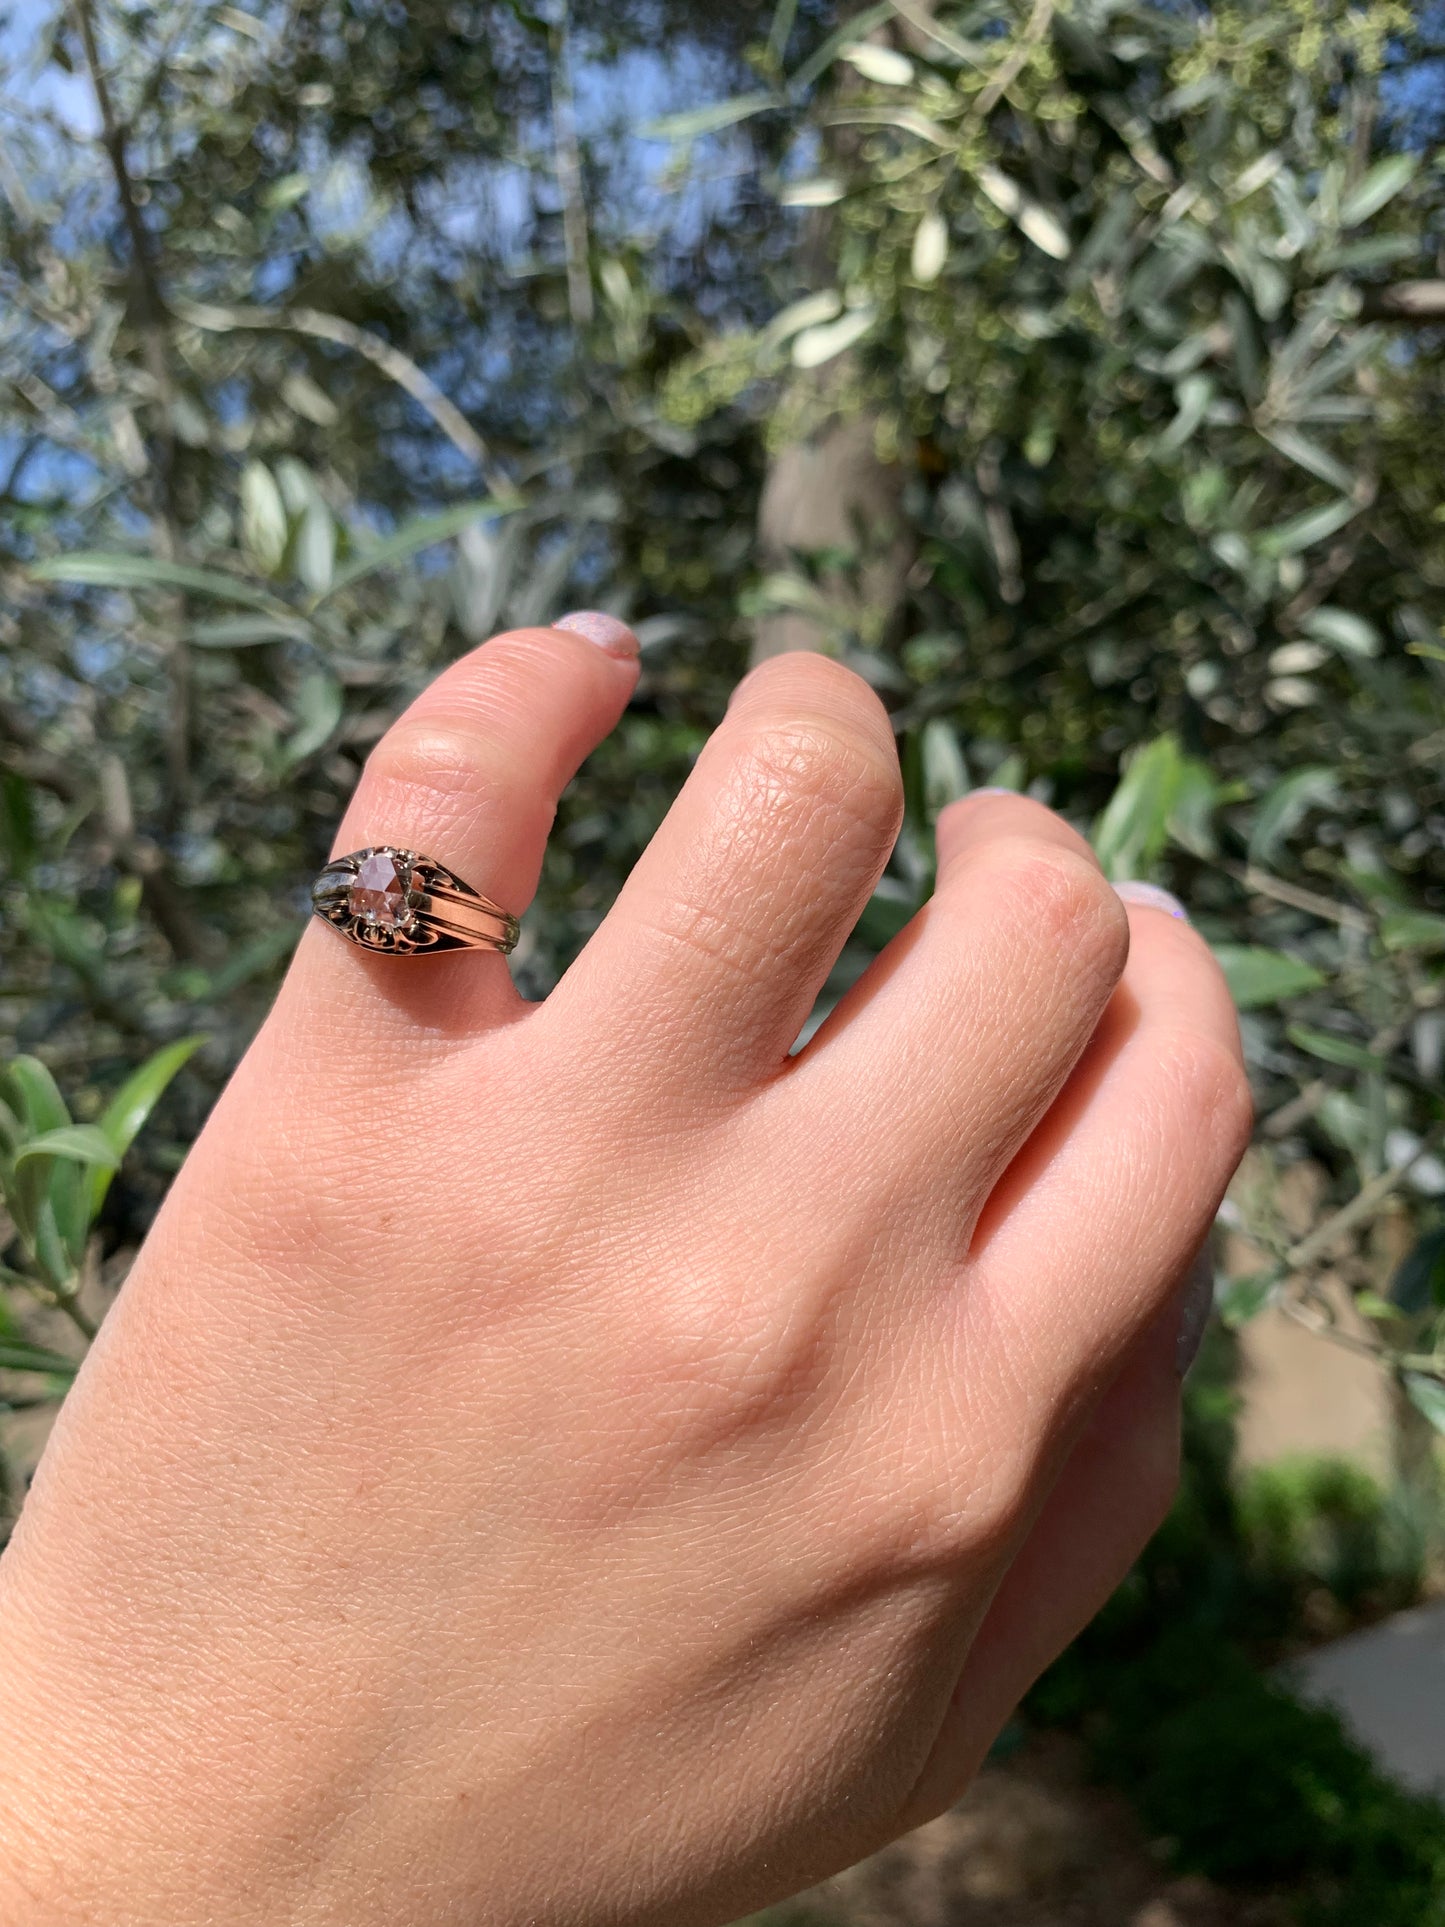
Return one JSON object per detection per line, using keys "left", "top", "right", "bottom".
{"left": 776, "top": 792, "right": 1129, "bottom": 1225}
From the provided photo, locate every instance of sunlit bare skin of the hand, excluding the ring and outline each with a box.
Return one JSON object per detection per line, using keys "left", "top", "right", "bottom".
{"left": 0, "top": 624, "right": 1248, "bottom": 1927}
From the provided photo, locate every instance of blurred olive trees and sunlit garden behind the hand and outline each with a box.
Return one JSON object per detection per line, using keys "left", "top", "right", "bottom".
{"left": 0, "top": 0, "right": 1445, "bottom": 1927}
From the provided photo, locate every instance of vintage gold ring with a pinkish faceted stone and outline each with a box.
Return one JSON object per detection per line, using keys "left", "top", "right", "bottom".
{"left": 310, "top": 844, "right": 518, "bottom": 956}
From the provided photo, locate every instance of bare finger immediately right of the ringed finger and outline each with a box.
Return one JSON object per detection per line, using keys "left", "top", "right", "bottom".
{"left": 543, "top": 653, "right": 902, "bottom": 1102}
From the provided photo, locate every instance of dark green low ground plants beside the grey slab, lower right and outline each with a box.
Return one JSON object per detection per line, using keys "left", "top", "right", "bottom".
{"left": 1027, "top": 1364, "right": 1445, "bottom": 1927}
